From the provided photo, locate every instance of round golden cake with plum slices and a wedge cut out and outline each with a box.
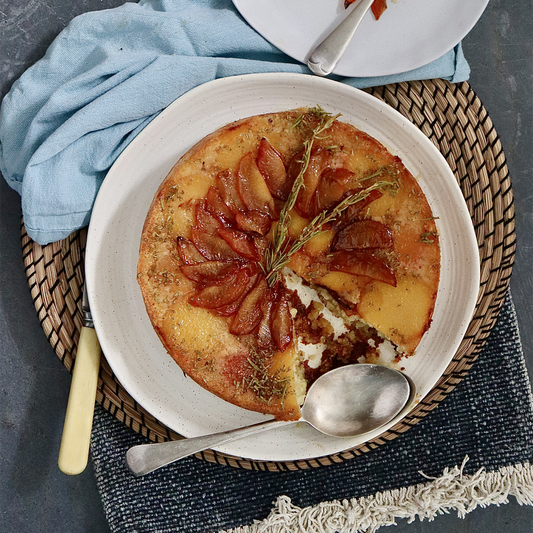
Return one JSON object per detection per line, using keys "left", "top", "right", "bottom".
{"left": 138, "top": 110, "right": 440, "bottom": 419}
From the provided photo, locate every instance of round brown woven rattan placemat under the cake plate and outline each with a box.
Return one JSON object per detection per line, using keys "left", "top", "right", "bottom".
{"left": 22, "top": 80, "right": 515, "bottom": 471}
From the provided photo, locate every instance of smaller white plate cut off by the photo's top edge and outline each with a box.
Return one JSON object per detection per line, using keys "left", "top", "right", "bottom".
{"left": 233, "top": 0, "right": 488, "bottom": 77}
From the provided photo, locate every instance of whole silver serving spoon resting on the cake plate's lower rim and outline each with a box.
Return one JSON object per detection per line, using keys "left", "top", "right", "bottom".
{"left": 126, "top": 364, "right": 414, "bottom": 476}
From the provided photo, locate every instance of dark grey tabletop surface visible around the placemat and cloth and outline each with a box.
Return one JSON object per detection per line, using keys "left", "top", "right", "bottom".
{"left": 0, "top": 0, "right": 533, "bottom": 533}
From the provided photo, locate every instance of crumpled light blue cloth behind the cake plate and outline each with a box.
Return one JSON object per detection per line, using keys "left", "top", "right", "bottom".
{"left": 0, "top": 0, "right": 470, "bottom": 244}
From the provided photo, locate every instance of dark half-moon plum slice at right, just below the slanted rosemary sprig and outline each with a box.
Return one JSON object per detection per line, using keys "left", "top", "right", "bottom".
{"left": 331, "top": 219, "right": 394, "bottom": 252}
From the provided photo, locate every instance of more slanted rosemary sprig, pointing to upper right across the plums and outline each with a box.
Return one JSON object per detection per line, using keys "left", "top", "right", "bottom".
{"left": 266, "top": 179, "right": 394, "bottom": 286}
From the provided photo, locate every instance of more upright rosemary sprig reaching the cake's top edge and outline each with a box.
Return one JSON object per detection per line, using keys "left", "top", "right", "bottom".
{"left": 265, "top": 106, "right": 340, "bottom": 286}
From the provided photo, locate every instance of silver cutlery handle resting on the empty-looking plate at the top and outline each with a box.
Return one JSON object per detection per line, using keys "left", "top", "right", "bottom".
{"left": 307, "top": 0, "right": 374, "bottom": 76}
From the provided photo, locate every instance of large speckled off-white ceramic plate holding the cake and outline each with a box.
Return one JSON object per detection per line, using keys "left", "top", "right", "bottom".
{"left": 86, "top": 74, "right": 479, "bottom": 461}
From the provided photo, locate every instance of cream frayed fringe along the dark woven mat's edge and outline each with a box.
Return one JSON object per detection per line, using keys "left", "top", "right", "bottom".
{"left": 220, "top": 457, "right": 533, "bottom": 533}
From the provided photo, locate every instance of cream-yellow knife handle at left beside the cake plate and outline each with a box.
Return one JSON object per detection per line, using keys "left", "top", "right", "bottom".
{"left": 57, "top": 327, "right": 101, "bottom": 476}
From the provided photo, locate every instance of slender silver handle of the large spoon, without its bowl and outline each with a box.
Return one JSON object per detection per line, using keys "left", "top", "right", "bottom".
{"left": 126, "top": 420, "right": 293, "bottom": 476}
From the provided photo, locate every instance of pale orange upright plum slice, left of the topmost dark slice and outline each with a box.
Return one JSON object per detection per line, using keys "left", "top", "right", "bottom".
{"left": 237, "top": 152, "right": 275, "bottom": 215}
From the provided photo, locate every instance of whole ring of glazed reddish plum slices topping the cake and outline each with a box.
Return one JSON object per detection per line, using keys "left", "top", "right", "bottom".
{"left": 177, "top": 148, "right": 396, "bottom": 351}
